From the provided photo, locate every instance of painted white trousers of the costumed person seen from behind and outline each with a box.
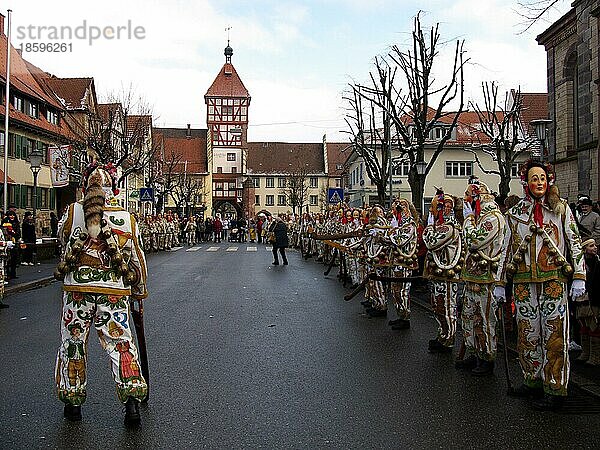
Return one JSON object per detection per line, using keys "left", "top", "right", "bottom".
{"left": 56, "top": 292, "right": 148, "bottom": 405}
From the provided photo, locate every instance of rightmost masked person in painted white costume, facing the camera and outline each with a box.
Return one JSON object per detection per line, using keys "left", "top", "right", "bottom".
{"left": 494, "top": 161, "right": 585, "bottom": 409}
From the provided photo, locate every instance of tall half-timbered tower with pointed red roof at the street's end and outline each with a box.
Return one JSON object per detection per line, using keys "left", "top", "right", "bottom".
{"left": 204, "top": 41, "right": 250, "bottom": 215}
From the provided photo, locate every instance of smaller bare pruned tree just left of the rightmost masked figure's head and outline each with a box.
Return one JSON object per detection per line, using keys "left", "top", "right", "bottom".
{"left": 465, "top": 82, "right": 539, "bottom": 198}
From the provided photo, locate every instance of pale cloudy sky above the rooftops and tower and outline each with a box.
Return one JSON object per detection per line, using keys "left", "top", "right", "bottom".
{"left": 1, "top": 0, "right": 568, "bottom": 142}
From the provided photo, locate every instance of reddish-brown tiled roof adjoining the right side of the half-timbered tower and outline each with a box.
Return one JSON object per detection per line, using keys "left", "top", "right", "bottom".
{"left": 247, "top": 142, "right": 325, "bottom": 174}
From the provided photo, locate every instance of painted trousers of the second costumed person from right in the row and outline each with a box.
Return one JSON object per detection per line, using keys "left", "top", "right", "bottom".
{"left": 461, "top": 282, "right": 498, "bottom": 361}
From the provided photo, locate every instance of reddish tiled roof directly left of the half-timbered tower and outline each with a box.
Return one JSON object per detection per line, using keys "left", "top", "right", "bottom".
{"left": 152, "top": 128, "right": 208, "bottom": 174}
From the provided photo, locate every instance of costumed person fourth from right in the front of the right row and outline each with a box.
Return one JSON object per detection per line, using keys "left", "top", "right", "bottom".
{"left": 387, "top": 198, "right": 419, "bottom": 330}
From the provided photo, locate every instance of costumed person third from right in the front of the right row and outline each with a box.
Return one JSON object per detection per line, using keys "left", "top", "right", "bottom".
{"left": 423, "top": 189, "right": 464, "bottom": 353}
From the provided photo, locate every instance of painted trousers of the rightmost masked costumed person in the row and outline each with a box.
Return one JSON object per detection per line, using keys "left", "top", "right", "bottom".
{"left": 514, "top": 280, "right": 569, "bottom": 396}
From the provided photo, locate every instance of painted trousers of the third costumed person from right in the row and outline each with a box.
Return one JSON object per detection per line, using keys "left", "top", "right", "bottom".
{"left": 431, "top": 280, "right": 458, "bottom": 347}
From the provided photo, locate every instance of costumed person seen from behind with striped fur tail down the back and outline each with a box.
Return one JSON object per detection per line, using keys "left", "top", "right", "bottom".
{"left": 55, "top": 163, "right": 148, "bottom": 424}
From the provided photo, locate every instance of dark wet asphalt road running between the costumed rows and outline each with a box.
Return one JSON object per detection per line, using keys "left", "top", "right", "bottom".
{"left": 0, "top": 243, "right": 600, "bottom": 449}
